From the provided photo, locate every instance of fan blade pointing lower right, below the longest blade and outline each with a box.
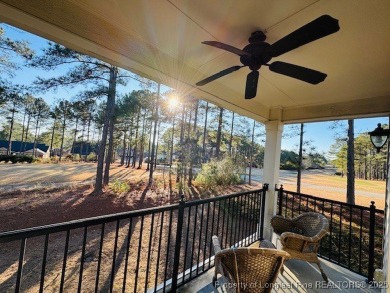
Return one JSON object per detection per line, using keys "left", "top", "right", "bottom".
{"left": 269, "top": 61, "right": 327, "bottom": 84}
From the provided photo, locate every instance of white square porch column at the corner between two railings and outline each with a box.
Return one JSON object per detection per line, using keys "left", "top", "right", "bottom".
{"left": 263, "top": 120, "right": 283, "bottom": 240}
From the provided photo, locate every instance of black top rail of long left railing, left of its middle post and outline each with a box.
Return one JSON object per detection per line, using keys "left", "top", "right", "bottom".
{"left": 0, "top": 204, "right": 179, "bottom": 243}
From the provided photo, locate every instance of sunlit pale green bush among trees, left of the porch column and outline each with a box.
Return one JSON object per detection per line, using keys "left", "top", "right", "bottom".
{"left": 194, "top": 157, "right": 243, "bottom": 188}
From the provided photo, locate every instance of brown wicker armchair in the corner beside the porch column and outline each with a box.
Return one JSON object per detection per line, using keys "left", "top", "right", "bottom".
{"left": 271, "top": 212, "right": 329, "bottom": 282}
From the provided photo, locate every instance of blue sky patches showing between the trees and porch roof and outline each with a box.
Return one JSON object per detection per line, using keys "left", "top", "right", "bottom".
{"left": 5, "top": 25, "right": 389, "bottom": 154}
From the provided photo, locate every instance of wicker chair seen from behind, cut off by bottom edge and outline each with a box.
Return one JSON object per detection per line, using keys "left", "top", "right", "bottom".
{"left": 212, "top": 236, "right": 288, "bottom": 293}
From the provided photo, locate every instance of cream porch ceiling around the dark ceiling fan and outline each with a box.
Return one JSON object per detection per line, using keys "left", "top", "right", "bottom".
{"left": 0, "top": 0, "right": 390, "bottom": 123}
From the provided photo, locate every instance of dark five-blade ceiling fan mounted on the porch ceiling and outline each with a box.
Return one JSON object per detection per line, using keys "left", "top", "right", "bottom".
{"left": 196, "top": 15, "right": 340, "bottom": 99}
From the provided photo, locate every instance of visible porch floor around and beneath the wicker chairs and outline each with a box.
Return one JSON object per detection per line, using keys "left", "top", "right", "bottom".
{"left": 178, "top": 259, "right": 380, "bottom": 293}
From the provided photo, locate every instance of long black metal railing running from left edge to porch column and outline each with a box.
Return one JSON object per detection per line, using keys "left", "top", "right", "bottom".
{"left": 0, "top": 185, "right": 267, "bottom": 293}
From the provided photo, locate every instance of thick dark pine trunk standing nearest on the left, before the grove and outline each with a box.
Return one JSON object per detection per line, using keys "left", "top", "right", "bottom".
{"left": 103, "top": 66, "right": 118, "bottom": 186}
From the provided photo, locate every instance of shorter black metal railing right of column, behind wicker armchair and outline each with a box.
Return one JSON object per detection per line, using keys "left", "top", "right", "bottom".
{"left": 276, "top": 185, "right": 384, "bottom": 282}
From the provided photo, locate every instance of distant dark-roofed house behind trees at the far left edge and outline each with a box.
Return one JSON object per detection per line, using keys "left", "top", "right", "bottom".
{"left": 0, "top": 140, "right": 50, "bottom": 158}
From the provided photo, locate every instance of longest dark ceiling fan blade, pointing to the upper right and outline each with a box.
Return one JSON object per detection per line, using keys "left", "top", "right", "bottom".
{"left": 270, "top": 15, "right": 340, "bottom": 57}
